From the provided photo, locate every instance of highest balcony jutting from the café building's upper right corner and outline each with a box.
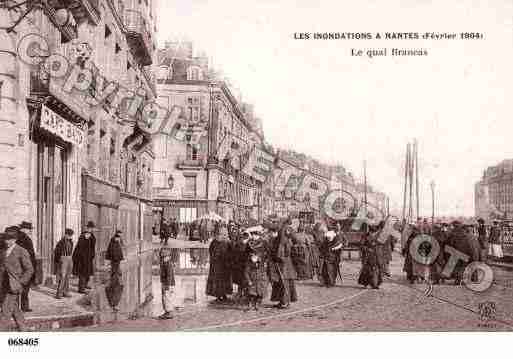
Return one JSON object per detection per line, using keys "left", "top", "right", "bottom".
{"left": 123, "top": 10, "right": 153, "bottom": 66}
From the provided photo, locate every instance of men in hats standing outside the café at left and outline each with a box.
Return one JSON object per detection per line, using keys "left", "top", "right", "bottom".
{"left": 0, "top": 221, "right": 124, "bottom": 330}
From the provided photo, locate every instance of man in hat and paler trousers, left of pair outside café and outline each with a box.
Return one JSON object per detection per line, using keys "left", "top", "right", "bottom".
{"left": 54, "top": 228, "right": 74, "bottom": 299}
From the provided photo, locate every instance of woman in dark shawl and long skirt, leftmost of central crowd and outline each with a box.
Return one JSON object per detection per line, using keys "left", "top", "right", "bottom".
{"left": 206, "top": 226, "right": 233, "bottom": 302}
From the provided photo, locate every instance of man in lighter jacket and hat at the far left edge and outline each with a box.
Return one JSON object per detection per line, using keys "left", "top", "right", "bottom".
{"left": 0, "top": 228, "right": 34, "bottom": 331}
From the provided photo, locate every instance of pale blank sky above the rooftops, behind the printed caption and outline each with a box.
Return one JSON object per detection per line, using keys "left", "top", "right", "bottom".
{"left": 158, "top": 0, "right": 513, "bottom": 216}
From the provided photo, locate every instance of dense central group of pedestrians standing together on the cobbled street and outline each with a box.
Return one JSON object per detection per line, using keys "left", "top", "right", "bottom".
{"left": 201, "top": 219, "right": 368, "bottom": 310}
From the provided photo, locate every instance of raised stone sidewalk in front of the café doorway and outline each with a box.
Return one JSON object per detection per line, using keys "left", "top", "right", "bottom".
{"left": 0, "top": 281, "right": 95, "bottom": 331}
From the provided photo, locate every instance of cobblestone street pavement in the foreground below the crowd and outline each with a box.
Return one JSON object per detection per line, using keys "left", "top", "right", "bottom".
{"left": 77, "top": 254, "right": 513, "bottom": 331}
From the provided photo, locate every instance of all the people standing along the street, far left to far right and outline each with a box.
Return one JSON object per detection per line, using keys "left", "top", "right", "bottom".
{"left": 0, "top": 214, "right": 508, "bottom": 329}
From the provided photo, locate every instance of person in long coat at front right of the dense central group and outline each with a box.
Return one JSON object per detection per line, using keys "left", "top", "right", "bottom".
{"left": 269, "top": 225, "right": 298, "bottom": 309}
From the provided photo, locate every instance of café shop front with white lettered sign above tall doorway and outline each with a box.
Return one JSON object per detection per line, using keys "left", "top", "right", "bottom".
{"left": 29, "top": 101, "right": 85, "bottom": 282}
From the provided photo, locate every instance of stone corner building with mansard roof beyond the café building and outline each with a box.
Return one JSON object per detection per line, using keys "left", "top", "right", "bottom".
{"left": 153, "top": 42, "right": 272, "bottom": 223}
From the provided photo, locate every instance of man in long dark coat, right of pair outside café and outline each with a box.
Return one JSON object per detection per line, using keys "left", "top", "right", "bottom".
{"left": 73, "top": 221, "right": 96, "bottom": 294}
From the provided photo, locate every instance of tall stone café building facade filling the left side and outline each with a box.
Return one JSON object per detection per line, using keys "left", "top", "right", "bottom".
{"left": 0, "top": 0, "right": 156, "bottom": 320}
